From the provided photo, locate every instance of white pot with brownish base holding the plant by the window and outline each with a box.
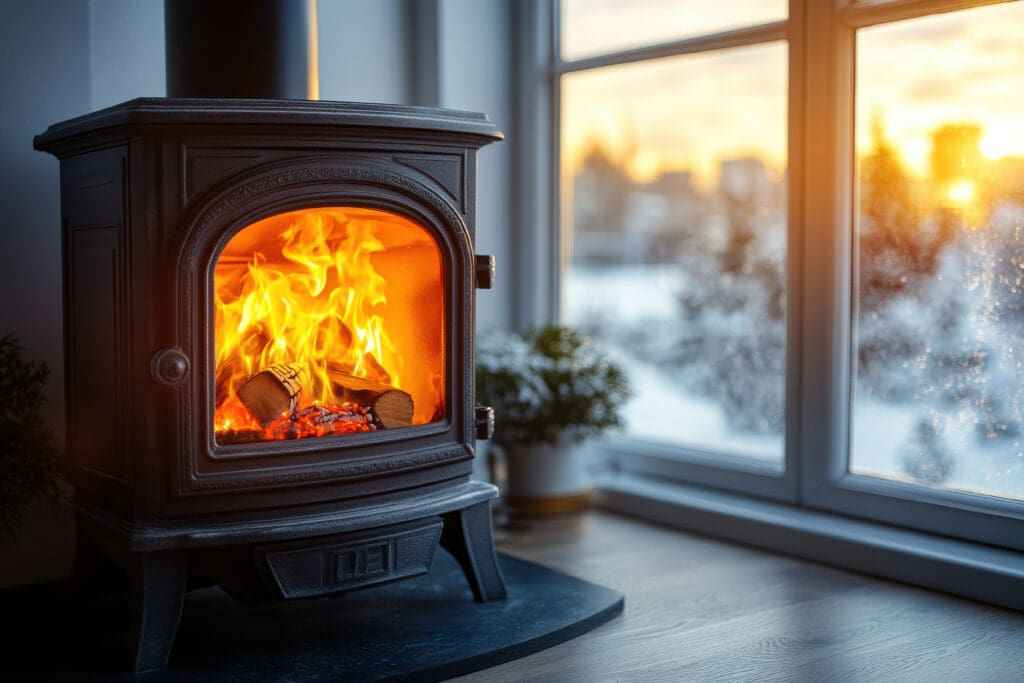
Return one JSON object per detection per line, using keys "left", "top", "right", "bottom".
{"left": 505, "top": 437, "right": 591, "bottom": 514}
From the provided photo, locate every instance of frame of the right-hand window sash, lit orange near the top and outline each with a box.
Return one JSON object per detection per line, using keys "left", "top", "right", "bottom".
{"left": 791, "top": 0, "right": 1024, "bottom": 550}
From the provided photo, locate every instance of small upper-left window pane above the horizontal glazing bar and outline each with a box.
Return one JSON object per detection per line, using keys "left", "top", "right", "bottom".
{"left": 561, "top": 0, "right": 787, "bottom": 60}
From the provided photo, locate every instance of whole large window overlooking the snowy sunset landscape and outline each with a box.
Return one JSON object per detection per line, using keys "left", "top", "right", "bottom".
{"left": 551, "top": 0, "right": 1024, "bottom": 549}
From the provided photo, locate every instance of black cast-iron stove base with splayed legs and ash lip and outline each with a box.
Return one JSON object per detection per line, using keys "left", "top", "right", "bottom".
{"left": 76, "top": 481, "right": 506, "bottom": 673}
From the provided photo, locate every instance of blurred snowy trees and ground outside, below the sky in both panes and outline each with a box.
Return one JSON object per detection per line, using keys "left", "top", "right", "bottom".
{"left": 563, "top": 157, "right": 1024, "bottom": 500}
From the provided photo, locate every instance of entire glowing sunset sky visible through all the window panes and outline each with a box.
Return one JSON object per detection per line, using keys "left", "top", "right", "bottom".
{"left": 562, "top": 0, "right": 1024, "bottom": 186}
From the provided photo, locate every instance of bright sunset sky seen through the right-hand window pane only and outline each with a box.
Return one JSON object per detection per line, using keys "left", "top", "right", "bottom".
{"left": 857, "top": 2, "right": 1024, "bottom": 174}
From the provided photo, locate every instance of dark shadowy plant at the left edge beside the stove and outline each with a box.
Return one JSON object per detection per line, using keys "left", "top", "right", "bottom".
{"left": 0, "top": 335, "right": 60, "bottom": 537}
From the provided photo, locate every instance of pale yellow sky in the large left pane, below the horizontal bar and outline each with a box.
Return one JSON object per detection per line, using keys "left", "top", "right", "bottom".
{"left": 562, "top": 42, "right": 787, "bottom": 183}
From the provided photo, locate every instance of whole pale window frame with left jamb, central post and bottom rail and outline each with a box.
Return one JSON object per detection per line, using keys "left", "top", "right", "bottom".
{"left": 513, "top": 0, "right": 1024, "bottom": 569}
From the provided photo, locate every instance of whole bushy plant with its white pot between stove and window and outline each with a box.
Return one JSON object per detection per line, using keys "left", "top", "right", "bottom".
{"left": 476, "top": 326, "right": 629, "bottom": 514}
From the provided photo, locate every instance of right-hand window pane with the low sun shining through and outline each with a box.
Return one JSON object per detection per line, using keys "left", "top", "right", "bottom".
{"left": 850, "top": 3, "right": 1024, "bottom": 499}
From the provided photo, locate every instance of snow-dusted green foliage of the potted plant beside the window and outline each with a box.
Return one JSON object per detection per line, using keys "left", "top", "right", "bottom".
{"left": 476, "top": 326, "right": 630, "bottom": 444}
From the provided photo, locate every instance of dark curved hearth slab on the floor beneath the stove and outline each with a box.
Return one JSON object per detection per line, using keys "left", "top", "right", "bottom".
{"left": 0, "top": 552, "right": 623, "bottom": 681}
